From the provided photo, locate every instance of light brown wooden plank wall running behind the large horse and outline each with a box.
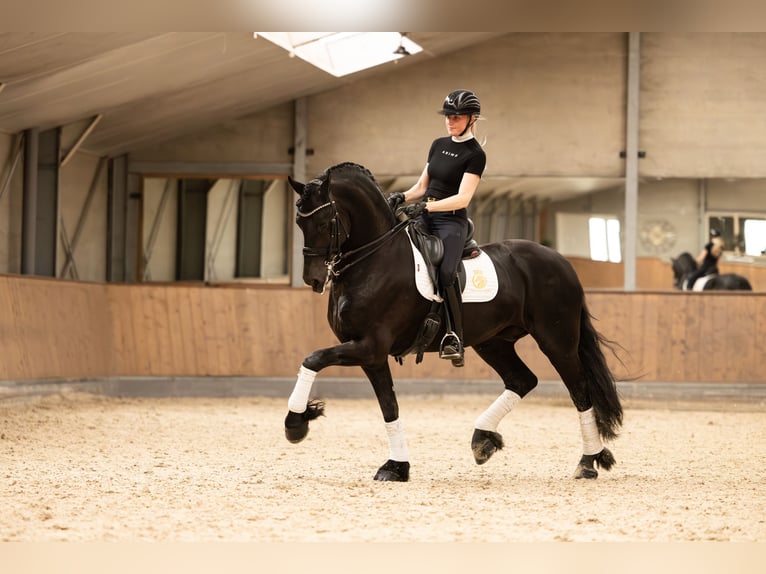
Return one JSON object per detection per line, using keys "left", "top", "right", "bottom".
{"left": 0, "top": 276, "right": 766, "bottom": 388}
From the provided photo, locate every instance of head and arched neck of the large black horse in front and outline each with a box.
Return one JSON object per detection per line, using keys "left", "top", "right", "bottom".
{"left": 288, "top": 163, "right": 396, "bottom": 293}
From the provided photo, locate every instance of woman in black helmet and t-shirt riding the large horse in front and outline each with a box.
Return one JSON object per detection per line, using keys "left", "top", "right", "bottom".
{"left": 389, "top": 90, "right": 487, "bottom": 367}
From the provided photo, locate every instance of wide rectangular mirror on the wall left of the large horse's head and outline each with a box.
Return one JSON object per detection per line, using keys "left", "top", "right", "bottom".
{"left": 140, "top": 178, "right": 291, "bottom": 283}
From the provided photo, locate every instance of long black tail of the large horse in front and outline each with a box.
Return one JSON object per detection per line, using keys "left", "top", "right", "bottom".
{"left": 577, "top": 303, "right": 622, "bottom": 441}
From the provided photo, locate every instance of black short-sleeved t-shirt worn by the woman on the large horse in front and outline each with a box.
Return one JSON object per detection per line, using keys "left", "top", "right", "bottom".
{"left": 426, "top": 136, "right": 487, "bottom": 213}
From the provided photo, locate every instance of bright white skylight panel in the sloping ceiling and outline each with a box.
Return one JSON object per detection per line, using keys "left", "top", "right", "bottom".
{"left": 253, "top": 32, "right": 423, "bottom": 77}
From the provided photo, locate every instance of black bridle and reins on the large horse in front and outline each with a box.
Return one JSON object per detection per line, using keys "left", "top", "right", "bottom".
{"left": 297, "top": 195, "right": 412, "bottom": 287}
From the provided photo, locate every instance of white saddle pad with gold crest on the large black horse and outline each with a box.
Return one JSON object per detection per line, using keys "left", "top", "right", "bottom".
{"left": 410, "top": 239, "right": 498, "bottom": 303}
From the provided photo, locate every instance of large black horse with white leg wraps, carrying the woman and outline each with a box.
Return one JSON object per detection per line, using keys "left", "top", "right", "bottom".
{"left": 285, "top": 163, "right": 623, "bottom": 481}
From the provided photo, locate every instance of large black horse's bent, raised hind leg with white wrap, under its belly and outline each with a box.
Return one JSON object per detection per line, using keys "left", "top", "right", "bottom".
{"left": 471, "top": 338, "right": 537, "bottom": 464}
